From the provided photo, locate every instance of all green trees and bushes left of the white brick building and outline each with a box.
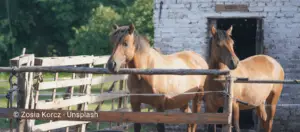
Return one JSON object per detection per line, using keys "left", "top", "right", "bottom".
{"left": 0, "top": 0, "right": 153, "bottom": 66}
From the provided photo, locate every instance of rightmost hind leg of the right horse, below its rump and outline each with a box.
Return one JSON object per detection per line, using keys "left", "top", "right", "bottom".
{"left": 265, "top": 92, "right": 281, "bottom": 132}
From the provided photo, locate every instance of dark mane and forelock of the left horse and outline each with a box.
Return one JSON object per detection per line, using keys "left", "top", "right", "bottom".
{"left": 110, "top": 26, "right": 150, "bottom": 52}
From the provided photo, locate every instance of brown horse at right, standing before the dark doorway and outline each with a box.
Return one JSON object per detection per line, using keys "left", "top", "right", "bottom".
{"left": 204, "top": 26, "right": 284, "bottom": 132}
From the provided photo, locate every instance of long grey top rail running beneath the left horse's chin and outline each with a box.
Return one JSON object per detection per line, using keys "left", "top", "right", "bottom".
{"left": 0, "top": 66, "right": 229, "bottom": 75}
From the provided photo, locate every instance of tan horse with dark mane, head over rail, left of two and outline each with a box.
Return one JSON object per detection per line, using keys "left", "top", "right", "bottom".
{"left": 107, "top": 24, "right": 208, "bottom": 132}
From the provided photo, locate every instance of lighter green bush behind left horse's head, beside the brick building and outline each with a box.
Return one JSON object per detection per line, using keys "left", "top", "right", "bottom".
{"left": 69, "top": 0, "right": 154, "bottom": 55}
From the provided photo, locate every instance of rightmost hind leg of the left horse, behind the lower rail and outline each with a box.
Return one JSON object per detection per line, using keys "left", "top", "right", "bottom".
{"left": 191, "top": 90, "right": 204, "bottom": 132}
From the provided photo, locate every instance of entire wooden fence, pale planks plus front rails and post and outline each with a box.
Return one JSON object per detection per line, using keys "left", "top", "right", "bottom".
{"left": 0, "top": 54, "right": 233, "bottom": 132}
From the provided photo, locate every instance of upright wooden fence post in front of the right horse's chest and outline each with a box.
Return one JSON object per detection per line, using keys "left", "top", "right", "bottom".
{"left": 222, "top": 75, "right": 233, "bottom": 132}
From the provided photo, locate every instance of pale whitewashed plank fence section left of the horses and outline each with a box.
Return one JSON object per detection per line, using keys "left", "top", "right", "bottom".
{"left": 10, "top": 54, "right": 128, "bottom": 132}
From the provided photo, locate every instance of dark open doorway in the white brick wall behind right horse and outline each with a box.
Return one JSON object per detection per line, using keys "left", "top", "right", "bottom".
{"left": 216, "top": 18, "right": 259, "bottom": 129}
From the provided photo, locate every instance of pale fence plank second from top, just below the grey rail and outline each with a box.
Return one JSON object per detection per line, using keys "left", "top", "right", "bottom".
{"left": 39, "top": 75, "right": 128, "bottom": 90}
